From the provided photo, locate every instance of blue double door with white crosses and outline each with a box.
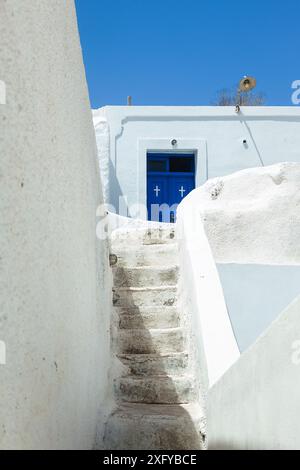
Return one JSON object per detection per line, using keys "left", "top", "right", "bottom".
{"left": 147, "top": 153, "right": 195, "bottom": 222}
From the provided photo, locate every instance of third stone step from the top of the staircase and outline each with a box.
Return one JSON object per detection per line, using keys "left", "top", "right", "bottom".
{"left": 113, "top": 266, "right": 178, "bottom": 287}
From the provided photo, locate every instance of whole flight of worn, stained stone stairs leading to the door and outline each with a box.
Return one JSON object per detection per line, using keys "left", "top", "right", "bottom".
{"left": 104, "top": 225, "right": 204, "bottom": 450}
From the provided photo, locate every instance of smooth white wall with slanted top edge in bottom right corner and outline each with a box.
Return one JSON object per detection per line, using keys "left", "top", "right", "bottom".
{"left": 208, "top": 298, "right": 300, "bottom": 450}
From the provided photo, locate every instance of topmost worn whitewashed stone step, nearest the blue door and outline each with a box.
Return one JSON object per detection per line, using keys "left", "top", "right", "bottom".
{"left": 111, "top": 224, "right": 176, "bottom": 249}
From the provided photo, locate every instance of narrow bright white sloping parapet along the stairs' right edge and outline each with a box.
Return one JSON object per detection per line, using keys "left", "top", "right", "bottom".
{"left": 177, "top": 197, "right": 240, "bottom": 388}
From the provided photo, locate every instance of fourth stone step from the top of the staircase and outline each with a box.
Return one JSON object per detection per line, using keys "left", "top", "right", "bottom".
{"left": 113, "top": 286, "right": 177, "bottom": 308}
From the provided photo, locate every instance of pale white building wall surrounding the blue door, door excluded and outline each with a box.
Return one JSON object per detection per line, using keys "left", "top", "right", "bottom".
{"left": 94, "top": 106, "right": 300, "bottom": 215}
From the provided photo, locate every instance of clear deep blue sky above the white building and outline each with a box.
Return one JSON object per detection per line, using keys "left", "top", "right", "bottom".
{"left": 76, "top": 0, "right": 300, "bottom": 108}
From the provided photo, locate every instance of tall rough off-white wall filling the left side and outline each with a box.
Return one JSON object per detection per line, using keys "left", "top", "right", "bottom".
{"left": 0, "top": 0, "right": 110, "bottom": 449}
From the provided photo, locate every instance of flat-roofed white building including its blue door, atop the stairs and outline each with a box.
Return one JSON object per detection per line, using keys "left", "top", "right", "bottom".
{"left": 94, "top": 106, "right": 300, "bottom": 222}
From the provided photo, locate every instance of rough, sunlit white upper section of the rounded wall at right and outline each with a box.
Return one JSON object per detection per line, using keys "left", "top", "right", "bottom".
{"left": 195, "top": 162, "right": 300, "bottom": 266}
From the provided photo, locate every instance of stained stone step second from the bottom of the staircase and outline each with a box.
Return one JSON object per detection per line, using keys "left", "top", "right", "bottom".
{"left": 115, "top": 376, "right": 196, "bottom": 405}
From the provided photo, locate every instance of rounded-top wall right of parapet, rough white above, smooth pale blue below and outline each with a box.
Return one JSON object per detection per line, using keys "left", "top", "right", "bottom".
{"left": 183, "top": 163, "right": 300, "bottom": 351}
